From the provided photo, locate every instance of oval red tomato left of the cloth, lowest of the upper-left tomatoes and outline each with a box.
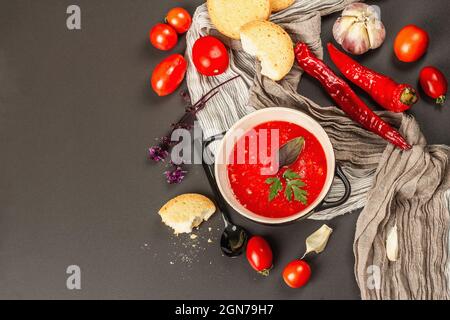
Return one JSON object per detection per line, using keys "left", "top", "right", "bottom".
{"left": 151, "top": 54, "right": 187, "bottom": 96}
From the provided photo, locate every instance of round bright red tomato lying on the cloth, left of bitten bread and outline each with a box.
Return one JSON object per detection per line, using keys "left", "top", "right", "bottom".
{"left": 192, "top": 36, "right": 230, "bottom": 76}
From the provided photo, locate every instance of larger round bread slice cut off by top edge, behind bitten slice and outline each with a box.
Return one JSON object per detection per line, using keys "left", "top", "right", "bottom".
{"left": 207, "top": 0, "right": 271, "bottom": 39}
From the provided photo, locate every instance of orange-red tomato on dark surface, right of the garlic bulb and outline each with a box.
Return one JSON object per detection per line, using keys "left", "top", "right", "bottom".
{"left": 394, "top": 24, "right": 429, "bottom": 62}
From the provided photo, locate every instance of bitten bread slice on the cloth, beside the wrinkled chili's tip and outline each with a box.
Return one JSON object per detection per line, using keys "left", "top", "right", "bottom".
{"left": 241, "top": 21, "right": 295, "bottom": 81}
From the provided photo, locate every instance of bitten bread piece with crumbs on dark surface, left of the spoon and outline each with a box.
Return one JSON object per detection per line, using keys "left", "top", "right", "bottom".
{"left": 158, "top": 193, "right": 216, "bottom": 234}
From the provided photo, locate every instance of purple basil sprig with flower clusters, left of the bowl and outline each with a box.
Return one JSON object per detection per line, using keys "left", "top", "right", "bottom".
{"left": 147, "top": 75, "right": 240, "bottom": 184}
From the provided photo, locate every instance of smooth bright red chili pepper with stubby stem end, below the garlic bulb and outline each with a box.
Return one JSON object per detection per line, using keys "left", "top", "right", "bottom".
{"left": 328, "top": 43, "right": 418, "bottom": 112}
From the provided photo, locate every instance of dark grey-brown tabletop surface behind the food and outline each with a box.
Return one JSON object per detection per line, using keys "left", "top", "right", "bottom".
{"left": 0, "top": 0, "right": 450, "bottom": 299}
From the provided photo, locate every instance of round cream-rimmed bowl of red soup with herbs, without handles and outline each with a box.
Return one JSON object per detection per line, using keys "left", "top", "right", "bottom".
{"left": 215, "top": 107, "right": 344, "bottom": 224}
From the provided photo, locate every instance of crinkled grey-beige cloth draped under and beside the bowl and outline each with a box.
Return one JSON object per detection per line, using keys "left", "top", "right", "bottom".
{"left": 186, "top": 0, "right": 450, "bottom": 299}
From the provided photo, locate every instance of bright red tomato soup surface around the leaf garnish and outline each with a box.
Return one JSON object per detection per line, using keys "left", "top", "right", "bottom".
{"left": 227, "top": 121, "right": 327, "bottom": 218}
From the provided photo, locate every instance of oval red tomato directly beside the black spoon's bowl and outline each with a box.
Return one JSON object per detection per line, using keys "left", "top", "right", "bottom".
{"left": 247, "top": 236, "right": 273, "bottom": 276}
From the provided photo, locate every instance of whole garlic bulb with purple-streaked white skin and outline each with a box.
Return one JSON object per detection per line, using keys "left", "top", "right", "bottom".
{"left": 333, "top": 2, "right": 386, "bottom": 55}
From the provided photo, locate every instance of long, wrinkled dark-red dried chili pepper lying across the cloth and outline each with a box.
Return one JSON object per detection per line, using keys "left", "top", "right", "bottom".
{"left": 295, "top": 42, "right": 411, "bottom": 150}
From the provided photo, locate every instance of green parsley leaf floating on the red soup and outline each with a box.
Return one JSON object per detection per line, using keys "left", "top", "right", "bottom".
{"left": 266, "top": 169, "right": 308, "bottom": 205}
